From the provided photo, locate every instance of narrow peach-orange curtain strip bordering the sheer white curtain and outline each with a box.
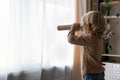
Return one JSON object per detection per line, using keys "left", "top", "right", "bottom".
{"left": 72, "top": 0, "right": 81, "bottom": 80}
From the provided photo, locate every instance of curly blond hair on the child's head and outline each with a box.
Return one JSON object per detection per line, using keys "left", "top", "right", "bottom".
{"left": 81, "top": 11, "right": 108, "bottom": 38}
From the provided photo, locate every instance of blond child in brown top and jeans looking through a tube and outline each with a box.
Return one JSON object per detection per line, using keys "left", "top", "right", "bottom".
{"left": 68, "top": 11, "right": 107, "bottom": 80}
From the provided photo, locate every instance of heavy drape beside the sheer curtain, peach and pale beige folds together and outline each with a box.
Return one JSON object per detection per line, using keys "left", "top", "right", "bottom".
{"left": 72, "top": 0, "right": 89, "bottom": 80}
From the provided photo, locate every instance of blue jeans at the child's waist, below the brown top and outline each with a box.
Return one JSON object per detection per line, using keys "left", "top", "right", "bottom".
{"left": 83, "top": 72, "right": 105, "bottom": 80}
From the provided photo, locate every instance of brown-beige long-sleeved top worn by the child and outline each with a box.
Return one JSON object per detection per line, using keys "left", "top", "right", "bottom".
{"left": 68, "top": 30, "right": 105, "bottom": 74}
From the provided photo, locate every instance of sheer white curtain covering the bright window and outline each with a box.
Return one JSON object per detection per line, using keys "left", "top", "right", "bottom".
{"left": 0, "top": 0, "right": 75, "bottom": 80}
